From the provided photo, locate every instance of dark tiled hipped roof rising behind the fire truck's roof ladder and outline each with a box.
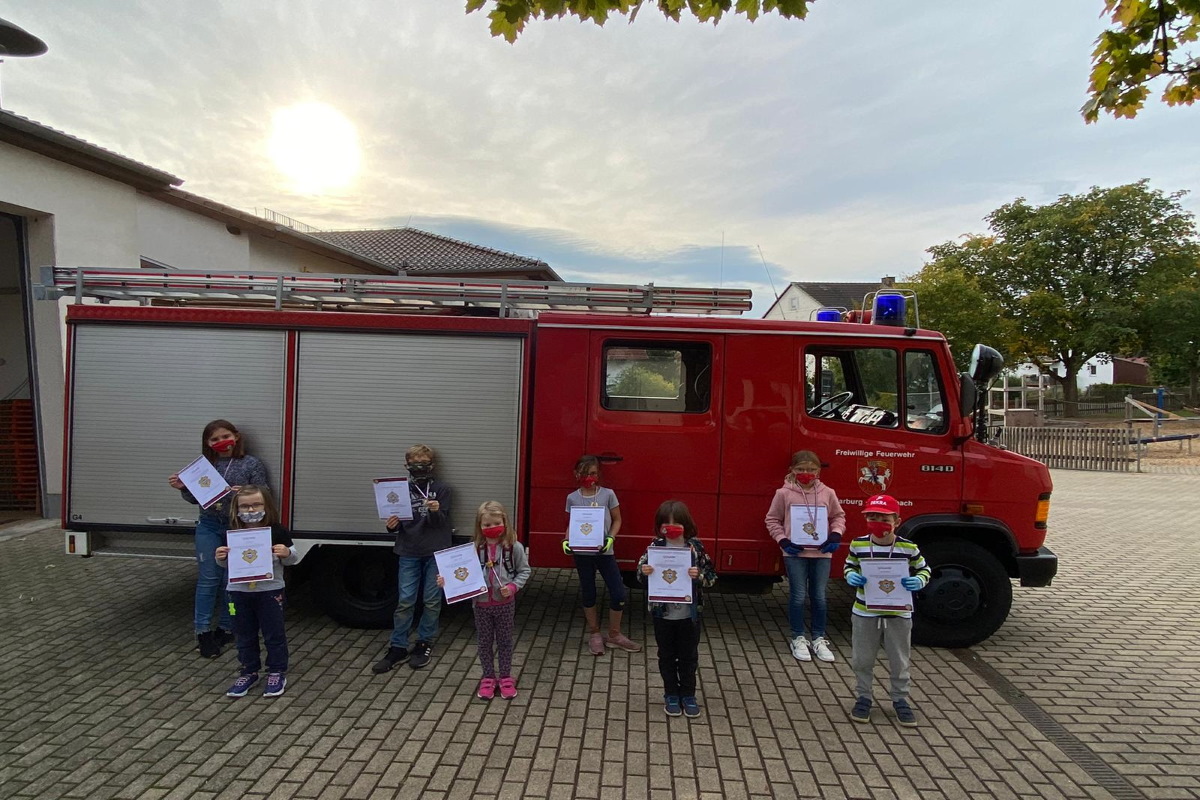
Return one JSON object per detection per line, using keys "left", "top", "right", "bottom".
{"left": 311, "top": 228, "right": 562, "bottom": 281}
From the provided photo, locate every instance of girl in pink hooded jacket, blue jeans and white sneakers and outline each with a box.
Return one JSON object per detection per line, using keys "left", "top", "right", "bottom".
{"left": 767, "top": 450, "right": 846, "bottom": 661}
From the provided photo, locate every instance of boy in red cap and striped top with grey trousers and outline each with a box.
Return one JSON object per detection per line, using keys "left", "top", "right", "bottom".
{"left": 845, "top": 494, "right": 929, "bottom": 727}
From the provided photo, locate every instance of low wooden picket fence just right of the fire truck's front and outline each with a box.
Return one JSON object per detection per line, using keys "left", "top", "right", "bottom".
{"left": 1000, "top": 428, "right": 1136, "bottom": 473}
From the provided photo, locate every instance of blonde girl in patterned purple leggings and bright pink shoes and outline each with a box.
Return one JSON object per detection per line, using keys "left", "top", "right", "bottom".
{"left": 438, "top": 500, "right": 533, "bottom": 700}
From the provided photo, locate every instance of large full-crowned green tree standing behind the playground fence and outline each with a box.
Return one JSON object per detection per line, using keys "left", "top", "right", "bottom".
{"left": 914, "top": 181, "right": 1196, "bottom": 402}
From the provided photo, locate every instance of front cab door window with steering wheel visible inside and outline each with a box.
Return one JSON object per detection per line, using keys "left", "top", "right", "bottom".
{"left": 804, "top": 347, "right": 900, "bottom": 428}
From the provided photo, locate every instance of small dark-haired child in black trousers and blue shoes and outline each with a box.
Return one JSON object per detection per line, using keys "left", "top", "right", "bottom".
{"left": 637, "top": 500, "right": 716, "bottom": 717}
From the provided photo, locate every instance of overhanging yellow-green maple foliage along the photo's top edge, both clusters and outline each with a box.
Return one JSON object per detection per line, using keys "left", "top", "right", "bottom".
{"left": 467, "top": 0, "right": 1200, "bottom": 122}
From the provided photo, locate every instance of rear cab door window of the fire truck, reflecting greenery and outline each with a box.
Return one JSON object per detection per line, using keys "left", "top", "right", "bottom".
{"left": 600, "top": 341, "right": 713, "bottom": 414}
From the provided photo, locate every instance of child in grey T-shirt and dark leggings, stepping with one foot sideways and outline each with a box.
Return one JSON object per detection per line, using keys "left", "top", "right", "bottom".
{"left": 563, "top": 456, "right": 642, "bottom": 656}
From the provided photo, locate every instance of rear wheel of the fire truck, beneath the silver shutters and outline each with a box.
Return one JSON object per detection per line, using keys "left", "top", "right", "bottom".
{"left": 312, "top": 547, "right": 396, "bottom": 628}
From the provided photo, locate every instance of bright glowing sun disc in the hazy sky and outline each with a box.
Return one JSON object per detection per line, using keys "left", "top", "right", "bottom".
{"left": 269, "top": 103, "right": 360, "bottom": 194}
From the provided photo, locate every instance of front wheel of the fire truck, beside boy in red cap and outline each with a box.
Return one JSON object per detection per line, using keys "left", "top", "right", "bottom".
{"left": 912, "top": 539, "right": 1013, "bottom": 648}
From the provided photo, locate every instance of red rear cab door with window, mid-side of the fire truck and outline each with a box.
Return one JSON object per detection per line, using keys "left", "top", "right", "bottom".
{"left": 580, "top": 330, "right": 724, "bottom": 569}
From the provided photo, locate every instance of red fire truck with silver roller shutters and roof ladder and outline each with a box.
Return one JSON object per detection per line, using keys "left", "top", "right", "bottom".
{"left": 40, "top": 267, "right": 1057, "bottom": 646}
